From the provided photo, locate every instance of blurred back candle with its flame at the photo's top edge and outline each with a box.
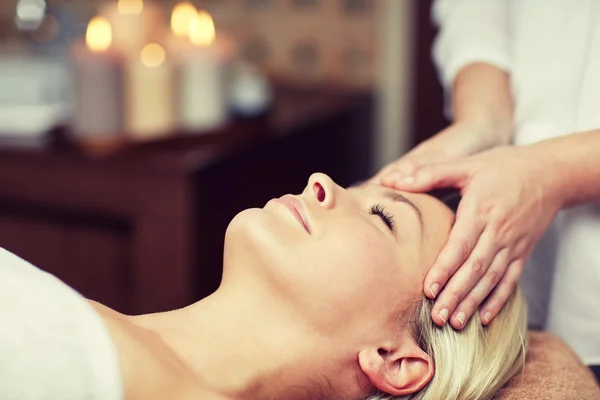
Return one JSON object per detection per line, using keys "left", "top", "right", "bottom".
{"left": 100, "top": 0, "right": 165, "bottom": 53}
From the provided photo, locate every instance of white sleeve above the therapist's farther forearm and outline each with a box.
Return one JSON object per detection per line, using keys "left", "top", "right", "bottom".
{"left": 432, "top": 0, "right": 511, "bottom": 89}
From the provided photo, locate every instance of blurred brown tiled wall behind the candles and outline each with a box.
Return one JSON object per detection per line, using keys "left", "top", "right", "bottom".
{"left": 0, "top": 0, "right": 381, "bottom": 87}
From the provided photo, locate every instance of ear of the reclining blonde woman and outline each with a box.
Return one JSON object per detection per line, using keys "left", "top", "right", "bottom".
{"left": 358, "top": 335, "right": 434, "bottom": 396}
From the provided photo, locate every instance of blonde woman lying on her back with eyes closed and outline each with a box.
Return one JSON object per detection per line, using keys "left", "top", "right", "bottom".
{"left": 0, "top": 174, "right": 525, "bottom": 400}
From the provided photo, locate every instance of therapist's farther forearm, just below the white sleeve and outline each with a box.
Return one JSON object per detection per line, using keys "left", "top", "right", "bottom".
{"left": 452, "top": 63, "right": 513, "bottom": 150}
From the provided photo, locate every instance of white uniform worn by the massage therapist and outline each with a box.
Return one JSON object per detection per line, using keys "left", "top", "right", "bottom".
{"left": 433, "top": 0, "right": 600, "bottom": 364}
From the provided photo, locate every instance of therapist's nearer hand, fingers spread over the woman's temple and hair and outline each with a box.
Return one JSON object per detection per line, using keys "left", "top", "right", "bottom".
{"left": 382, "top": 146, "right": 562, "bottom": 329}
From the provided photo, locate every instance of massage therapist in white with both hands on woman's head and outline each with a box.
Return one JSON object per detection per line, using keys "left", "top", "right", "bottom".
{"left": 380, "top": 0, "right": 600, "bottom": 382}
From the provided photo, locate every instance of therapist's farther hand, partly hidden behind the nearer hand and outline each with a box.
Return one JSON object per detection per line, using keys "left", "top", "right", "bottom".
{"left": 372, "top": 118, "right": 496, "bottom": 182}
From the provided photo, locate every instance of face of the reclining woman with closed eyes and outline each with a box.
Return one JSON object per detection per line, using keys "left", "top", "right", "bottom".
{"left": 225, "top": 174, "right": 454, "bottom": 340}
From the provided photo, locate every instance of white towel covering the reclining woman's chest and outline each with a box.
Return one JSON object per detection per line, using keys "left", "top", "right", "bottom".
{"left": 0, "top": 248, "right": 123, "bottom": 400}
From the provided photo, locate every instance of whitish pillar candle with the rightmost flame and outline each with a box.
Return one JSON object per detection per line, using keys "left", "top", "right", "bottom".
{"left": 179, "top": 11, "right": 234, "bottom": 131}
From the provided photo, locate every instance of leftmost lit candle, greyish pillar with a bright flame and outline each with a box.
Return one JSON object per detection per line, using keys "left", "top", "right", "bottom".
{"left": 71, "top": 17, "right": 123, "bottom": 136}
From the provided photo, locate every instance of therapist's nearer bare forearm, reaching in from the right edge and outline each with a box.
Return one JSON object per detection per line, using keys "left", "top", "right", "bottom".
{"left": 531, "top": 129, "right": 600, "bottom": 208}
